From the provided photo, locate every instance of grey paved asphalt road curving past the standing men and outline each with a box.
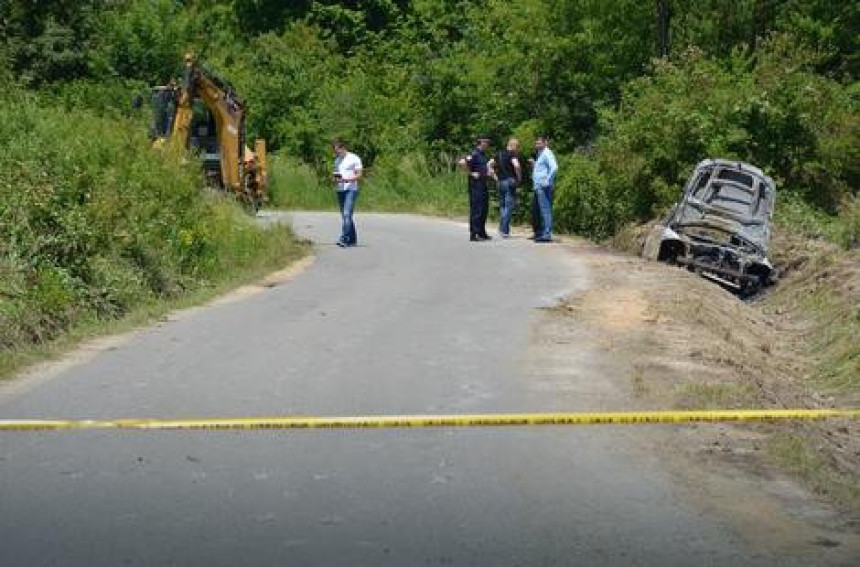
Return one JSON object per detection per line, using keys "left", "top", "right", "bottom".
{"left": 0, "top": 213, "right": 848, "bottom": 567}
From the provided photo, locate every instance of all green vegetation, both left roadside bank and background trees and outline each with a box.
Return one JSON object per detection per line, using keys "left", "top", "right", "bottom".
{"left": 0, "top": 0, "right": 860, "bottom": 362}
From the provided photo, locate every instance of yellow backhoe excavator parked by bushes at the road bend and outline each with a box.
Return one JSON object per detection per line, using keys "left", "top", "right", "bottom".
{"left": 152, "top": 54, "right": 267, "bottom": 212}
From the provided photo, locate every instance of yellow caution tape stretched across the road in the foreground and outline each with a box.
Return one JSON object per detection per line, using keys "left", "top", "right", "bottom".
{"left": 0, "top": 409, "right": 860, "bottom": 432}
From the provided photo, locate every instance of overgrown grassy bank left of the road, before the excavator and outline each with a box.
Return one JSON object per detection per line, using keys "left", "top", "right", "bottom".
{"left": 0, "top": 91, "right": 305, "bottom": 376}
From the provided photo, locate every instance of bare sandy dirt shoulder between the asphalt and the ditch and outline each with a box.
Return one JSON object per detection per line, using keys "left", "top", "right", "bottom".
{"left": 556, "top": 229, "right": 860, "bottom": 553}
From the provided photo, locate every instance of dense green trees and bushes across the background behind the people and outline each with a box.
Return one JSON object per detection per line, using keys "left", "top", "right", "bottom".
{"left": 0, "top": 0, "right": 860, "bottom": 240}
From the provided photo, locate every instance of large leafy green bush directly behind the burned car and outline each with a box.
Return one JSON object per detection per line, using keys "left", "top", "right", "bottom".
{"left": 559, "top": 36, "right": 860, "bottom": 240}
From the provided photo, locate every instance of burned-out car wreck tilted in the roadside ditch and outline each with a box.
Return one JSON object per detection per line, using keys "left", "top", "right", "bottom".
{"left": 643, "top": 159, "right": 776, "bottom": 296}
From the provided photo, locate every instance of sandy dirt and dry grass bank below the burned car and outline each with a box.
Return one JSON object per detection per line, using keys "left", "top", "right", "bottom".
{"left": 561, "top": 233, "right": 860, "bottom": 513}
